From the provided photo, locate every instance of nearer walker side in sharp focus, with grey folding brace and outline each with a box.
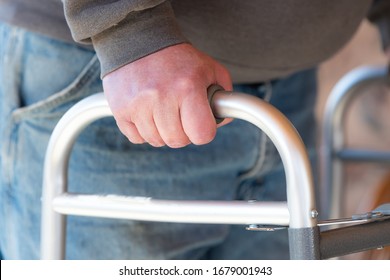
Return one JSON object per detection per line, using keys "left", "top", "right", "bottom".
{"left": 41, "top": 71, "right": 390, "bottom": 260}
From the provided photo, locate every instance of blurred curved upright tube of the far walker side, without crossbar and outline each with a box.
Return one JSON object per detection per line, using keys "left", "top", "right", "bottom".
{"left": 319, "top": 67, "right": 387, "bottom": 219}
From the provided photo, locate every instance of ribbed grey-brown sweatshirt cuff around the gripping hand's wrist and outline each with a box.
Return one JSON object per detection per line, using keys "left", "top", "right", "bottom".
{"left": 92, "top": 2, "right": 187, "bottom": 77}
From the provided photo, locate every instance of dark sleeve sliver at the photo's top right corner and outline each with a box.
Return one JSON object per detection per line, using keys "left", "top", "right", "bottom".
{"left": 368, "top": 0, "right": 390, "bottom": 50}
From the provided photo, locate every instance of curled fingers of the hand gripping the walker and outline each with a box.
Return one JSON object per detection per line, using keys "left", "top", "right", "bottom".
{"left": 114, "top": 86, "right": 217, "bottom": 148}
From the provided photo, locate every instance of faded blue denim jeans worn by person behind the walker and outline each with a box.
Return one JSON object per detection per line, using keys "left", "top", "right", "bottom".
{"left": 0, "top": 24, "right": 316, "bottom": 259}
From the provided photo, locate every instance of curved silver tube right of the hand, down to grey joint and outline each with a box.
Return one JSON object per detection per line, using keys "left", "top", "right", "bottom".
{"left": 212, "top": 91, "right": 317, "bottom": 228}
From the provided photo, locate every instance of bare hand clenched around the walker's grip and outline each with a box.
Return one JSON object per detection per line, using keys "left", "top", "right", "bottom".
{"left": 103, "top": 44, "right": 232, "bottom": 148}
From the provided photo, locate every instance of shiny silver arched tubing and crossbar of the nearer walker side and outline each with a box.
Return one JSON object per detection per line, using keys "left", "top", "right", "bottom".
{"left": 41, "top": 91, "right": 317, "bottom": 259}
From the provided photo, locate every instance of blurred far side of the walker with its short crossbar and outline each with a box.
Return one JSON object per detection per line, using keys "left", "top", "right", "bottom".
{"left": 320, "top": 66, "right": 390, "bottom": 218}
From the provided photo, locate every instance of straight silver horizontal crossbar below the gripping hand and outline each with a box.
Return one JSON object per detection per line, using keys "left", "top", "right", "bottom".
{"left": 53, "top": 194, "right": 289, "bottom": 226}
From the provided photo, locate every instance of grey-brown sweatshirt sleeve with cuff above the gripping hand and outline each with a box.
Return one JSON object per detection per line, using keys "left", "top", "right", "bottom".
{"left": 63, "top": 0, "right": 187, "bottom": 77}
